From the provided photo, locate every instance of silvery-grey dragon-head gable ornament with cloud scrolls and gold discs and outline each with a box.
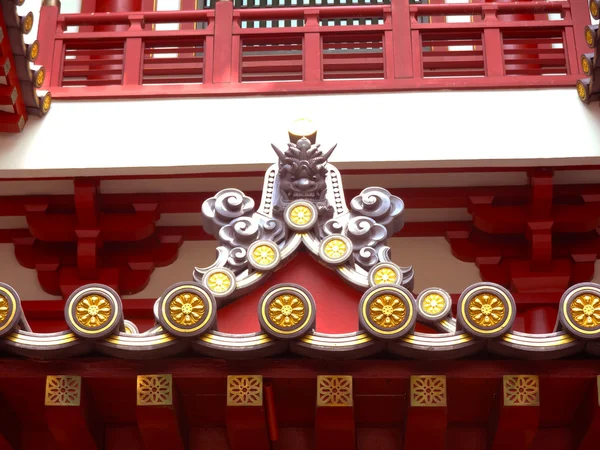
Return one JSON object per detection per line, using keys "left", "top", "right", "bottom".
{"left": 193, "top": 123, "right": 413, "bottom": 306}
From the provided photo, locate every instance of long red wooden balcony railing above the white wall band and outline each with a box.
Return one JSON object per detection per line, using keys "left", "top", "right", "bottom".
{"left": 39, "top": 0, "right": 589, "bottom": 98}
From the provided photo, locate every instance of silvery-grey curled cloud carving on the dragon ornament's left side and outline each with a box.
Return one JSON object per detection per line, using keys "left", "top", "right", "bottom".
{"left": 202, "top": 189, "right": 254, "bottom": 237}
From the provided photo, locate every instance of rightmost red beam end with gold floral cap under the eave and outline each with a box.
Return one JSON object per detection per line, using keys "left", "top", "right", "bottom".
{"left": 488, "top": 375, "right": 540, "bottom": 450}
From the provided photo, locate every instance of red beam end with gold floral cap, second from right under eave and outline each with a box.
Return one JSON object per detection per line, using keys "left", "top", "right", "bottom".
{"left": 404, "top": 375, "right": 448, "bottom": 450}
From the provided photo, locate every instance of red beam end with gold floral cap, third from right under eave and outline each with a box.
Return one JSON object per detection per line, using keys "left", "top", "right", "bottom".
{"left": 315, "top": 375, "right": 356, "bottom": 450}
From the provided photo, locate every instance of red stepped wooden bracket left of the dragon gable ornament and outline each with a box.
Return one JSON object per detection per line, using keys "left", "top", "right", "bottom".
{"left": 14, "top": 179, "right": 182, "bottom": 297}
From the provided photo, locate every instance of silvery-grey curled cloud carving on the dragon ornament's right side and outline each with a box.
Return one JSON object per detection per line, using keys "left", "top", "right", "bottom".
{"left": 350, "top": 187, "right": 404, "bottom": 236}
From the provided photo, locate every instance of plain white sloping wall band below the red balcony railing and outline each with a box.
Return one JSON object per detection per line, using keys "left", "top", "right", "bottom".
{"left": 0, "top": 87, "right": 600, "bottom": 177}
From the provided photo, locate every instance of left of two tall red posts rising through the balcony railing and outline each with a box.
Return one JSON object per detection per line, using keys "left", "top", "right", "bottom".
{"left": 213, "top": 0, "right": 233, "bottom": 83}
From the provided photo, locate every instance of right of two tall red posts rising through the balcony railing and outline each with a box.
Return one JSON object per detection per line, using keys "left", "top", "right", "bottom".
{"left": 386, "top": 0, "right": 412, "bottom": 78}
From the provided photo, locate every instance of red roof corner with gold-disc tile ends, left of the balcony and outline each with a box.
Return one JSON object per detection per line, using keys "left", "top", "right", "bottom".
{"left": 0, "top": 0, "right": 51, "bottom": 132}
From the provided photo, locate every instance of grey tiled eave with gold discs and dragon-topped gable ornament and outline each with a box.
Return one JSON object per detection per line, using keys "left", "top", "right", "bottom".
{"left": 0, "top": 124, "right": 600, "bottom": 359}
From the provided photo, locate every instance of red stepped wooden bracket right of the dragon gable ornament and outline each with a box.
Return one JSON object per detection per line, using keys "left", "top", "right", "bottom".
{"left": 446, "top": 170, "right": 600, "bottom": 292}
